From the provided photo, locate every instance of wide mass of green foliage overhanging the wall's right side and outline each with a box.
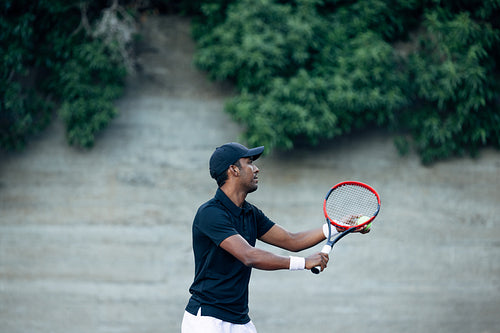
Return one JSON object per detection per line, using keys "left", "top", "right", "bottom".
{"left": 195, "top": 0, "right": 500, "bottom": 163}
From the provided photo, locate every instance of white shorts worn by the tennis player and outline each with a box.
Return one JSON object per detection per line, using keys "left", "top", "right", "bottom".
{"left": 181, "top": 309, "right": 257, "bottom": 333}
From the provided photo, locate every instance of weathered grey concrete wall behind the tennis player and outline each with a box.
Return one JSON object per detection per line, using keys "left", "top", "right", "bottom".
{"left": 0, "top": 16, "right": 500, "bottom": 333}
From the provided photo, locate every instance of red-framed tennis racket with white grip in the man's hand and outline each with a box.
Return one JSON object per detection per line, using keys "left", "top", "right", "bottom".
{"left": 311, "top": 181, "right": 380, "bottom": 274}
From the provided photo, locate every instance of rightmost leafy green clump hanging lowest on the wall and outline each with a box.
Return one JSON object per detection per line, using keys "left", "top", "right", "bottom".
{"left": 404, "top": 10, "right": 500, "bottom": 163}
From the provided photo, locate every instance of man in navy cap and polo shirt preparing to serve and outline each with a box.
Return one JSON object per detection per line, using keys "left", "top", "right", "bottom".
{"left": 182, "top": 142, "right": 368, "bottom": 333}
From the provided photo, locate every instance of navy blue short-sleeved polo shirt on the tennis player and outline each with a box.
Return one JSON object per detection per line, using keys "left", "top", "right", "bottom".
{"left": 186, "top": 188, "right": 274, "bottom": 324}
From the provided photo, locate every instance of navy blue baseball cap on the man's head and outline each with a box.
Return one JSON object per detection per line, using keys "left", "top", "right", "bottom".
{"left": 210, "top": 142, "right": 264, "bottom": 179}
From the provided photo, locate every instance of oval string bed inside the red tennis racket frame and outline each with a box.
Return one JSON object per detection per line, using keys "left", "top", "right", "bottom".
{"left": 325, "top": 184, "right": 379, "bottom": 227}
